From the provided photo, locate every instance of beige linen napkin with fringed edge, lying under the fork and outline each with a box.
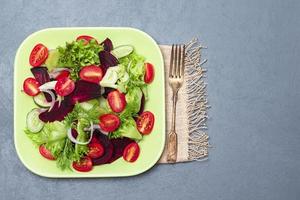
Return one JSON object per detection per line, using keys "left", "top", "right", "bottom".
{"left": 159, "top": 39, "right": 209, "bottom": 163}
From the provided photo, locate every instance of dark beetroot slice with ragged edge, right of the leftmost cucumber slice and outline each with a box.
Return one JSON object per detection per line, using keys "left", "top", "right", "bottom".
{"left": 39, "top": 101, "right": 74, "bottom": 122}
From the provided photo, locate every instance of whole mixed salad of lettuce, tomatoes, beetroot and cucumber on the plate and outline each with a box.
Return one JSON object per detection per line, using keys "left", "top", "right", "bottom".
{"left": 23, "top": 35, "right": 154, "bottom": 172}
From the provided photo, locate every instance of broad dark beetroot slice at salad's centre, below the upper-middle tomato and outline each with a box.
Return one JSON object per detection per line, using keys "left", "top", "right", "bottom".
{"left": 65, "top": 80, "right": 101, "bottom": 105}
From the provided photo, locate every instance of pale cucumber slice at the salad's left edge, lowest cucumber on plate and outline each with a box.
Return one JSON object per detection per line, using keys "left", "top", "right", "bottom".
{"left": 26, "top": 108, "right": 45, "bottom": 133}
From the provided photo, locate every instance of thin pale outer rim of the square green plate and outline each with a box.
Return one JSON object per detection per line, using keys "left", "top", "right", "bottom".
{"left": 13, "top": 26, "right": 166, "bottom": 179}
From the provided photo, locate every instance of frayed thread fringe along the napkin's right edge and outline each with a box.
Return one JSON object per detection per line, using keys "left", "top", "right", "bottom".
{"left": 185, "top": 38, "right": 210, "bottom": 161}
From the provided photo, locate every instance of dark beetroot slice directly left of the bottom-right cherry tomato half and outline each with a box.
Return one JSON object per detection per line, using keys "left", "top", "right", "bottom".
{"left": 108, "top": 137, "right": 134, "bottom": 163}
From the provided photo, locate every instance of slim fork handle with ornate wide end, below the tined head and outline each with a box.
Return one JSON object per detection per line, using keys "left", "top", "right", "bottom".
{"left": 167, "top": 90, "right": 178, "bottom": 163}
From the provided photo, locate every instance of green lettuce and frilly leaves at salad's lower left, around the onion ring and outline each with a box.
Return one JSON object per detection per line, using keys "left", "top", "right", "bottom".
{"left": 25, "top": 104, "right": 99, "bottom": 169}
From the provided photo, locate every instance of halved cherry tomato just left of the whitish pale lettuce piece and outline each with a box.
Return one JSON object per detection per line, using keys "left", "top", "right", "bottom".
{"left": 79, "top": 65, "right": 103, "bottom": 83}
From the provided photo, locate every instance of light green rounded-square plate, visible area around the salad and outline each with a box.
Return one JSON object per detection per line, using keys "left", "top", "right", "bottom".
{"left": 14, "top": 27, "right": 165, "bottom": 178}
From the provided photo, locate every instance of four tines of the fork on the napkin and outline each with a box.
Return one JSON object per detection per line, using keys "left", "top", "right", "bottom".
{"left": 169, "top": 44, "right": 185, "bottom": 78}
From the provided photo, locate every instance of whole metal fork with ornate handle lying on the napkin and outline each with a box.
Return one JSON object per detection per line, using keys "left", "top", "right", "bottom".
{"left": 167, "top": 44, "right": 185, "bottom": 163}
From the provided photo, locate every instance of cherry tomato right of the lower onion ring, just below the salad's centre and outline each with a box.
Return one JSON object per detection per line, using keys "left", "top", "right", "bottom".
{"left": 99, "top": 114, "right": 121, "bottom": 132}
